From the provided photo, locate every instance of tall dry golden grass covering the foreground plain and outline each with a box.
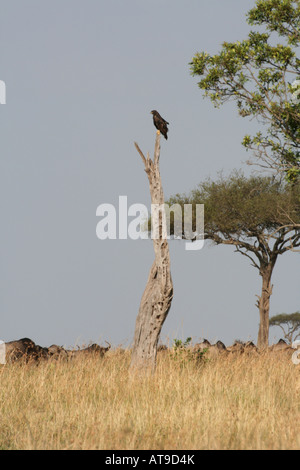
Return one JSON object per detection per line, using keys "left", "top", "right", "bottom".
{"left": 0, "top": 350, "right": 300, "bottom": 450}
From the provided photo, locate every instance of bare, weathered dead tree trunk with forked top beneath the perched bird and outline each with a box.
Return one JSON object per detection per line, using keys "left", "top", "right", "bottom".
{"left": 130, "top": 131, "right": 173, "bottom": 372}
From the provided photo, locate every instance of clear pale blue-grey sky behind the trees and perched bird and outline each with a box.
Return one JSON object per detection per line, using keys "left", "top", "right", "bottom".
{"left": 0, "top": 0, "right": 300, "bottom": 345}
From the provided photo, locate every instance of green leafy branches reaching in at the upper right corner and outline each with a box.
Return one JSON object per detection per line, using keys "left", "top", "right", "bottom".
{"left": 190, "top": 0, "right": 300, "bottom": 182}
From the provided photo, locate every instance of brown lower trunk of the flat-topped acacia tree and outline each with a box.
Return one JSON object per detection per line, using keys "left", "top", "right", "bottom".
{"left": 257, "top": 264, "right": 274, "bottom": 349}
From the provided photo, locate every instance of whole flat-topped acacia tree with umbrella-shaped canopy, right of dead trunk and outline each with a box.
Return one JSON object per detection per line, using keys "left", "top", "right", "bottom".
{"left": 168, "top": 173, "right": 300, "bottom": 348}
